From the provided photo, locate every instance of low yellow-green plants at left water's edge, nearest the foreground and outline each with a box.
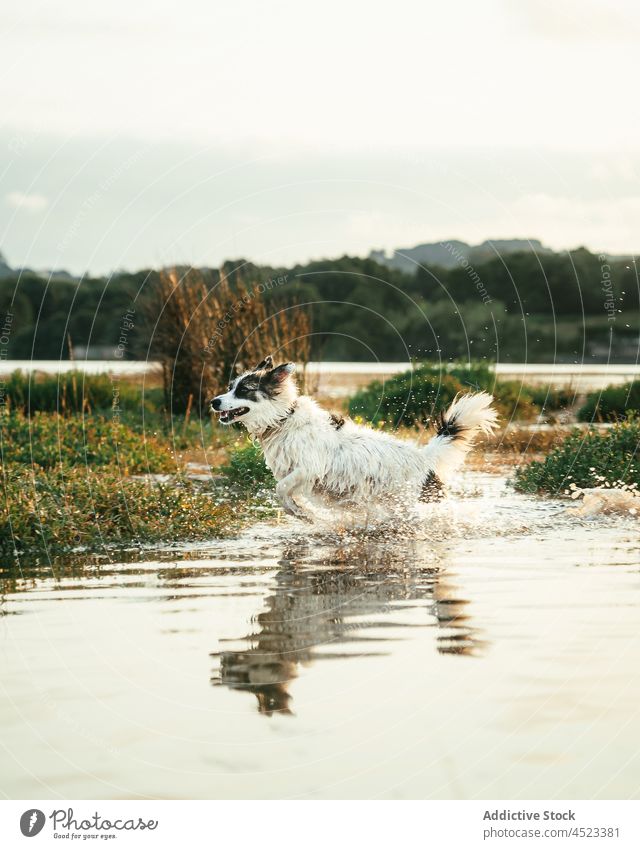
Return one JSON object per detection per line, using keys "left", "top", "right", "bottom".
{"left": 0, "top": 463, "right": 239, "bottom": 555}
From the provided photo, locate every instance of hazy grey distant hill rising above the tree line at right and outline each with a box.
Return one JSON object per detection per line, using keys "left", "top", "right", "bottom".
{"left": 369, "top": 239, "right": 553, "bottom": 273}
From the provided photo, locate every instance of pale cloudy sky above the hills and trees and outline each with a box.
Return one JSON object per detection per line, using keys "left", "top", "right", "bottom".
{"left": 0, "top": 0, "right": 640, "bottom": 273}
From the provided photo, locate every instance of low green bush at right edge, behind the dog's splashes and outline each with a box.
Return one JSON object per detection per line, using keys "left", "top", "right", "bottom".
{"left": 514, "top": 417, "right": 640, "bottom": 495}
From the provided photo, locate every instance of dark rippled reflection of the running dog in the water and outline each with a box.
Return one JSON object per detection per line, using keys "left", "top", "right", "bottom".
{"left": 212, "top": 540, "right": 482, "bottom": 716}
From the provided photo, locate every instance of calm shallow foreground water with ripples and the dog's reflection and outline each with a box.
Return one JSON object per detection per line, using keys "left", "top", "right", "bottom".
{"left": 0, "top": 474, "right": 640, "bottom": 798}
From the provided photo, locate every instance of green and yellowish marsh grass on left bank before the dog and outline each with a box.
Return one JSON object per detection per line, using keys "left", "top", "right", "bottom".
{"left": 0, "top": 411, "right": 252, "bottom": 556}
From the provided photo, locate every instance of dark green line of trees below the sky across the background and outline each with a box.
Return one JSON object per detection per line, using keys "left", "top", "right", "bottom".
{"left": 0, "top": 248, "right": 640, "bottom": 362}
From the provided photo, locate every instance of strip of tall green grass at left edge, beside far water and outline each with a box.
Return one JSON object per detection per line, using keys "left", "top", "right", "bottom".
{"left": 4, "top": 371, "right": 163, "bottom": 415}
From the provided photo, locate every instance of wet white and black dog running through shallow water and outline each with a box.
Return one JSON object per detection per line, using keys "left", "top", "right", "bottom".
{"left": 211, "top": 357, "right": 497, "bottom": 518}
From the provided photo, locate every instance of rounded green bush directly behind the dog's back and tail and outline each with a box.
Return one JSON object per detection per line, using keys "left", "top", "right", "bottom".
{"left": 349, "top": 363, "right": 539, "bottom": 427}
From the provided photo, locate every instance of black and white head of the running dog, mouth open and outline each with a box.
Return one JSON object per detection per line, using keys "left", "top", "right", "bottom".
{"left": 210, "top": 357, "right": 298, "bottom": 429}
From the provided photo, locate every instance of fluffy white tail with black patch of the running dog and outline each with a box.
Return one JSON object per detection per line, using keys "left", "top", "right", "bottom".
{"left": 423, "top": 392, "right": 498, "bottom": 480}
